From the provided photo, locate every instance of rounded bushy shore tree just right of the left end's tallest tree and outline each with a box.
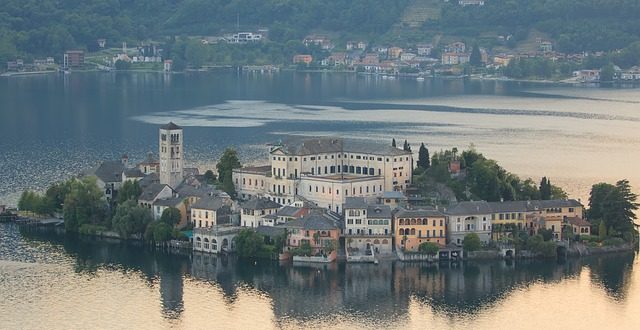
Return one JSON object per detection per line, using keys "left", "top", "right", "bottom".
{"left": 111, "top": 200, "right": 153, "bottom": 239}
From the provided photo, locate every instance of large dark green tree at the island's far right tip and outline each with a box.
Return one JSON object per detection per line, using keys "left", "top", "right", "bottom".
{"left": 587, "top": 180, "right": 638, "bottom": 238}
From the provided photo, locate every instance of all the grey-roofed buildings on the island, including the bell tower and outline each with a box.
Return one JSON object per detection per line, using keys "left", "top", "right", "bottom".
{"left": 15, "top": 123, "right": 616, "bottom": 263}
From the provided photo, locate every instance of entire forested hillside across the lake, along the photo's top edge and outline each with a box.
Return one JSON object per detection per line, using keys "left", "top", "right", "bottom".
{"left": 0, "top": 0, "right": 640, "bottom": 61}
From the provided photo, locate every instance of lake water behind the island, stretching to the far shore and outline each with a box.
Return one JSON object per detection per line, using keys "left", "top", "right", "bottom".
{"left": 0, "top": 72, "right": 640, "bottom": 204}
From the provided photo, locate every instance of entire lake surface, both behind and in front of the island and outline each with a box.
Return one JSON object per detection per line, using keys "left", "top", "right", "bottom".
{"left": 0, "top": 72, "right": 640, "bottom": 329}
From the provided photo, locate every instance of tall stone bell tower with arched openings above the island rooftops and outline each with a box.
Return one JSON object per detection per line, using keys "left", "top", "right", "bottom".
{"left": 159, "top": 122, "right": 184, "bottom": 189}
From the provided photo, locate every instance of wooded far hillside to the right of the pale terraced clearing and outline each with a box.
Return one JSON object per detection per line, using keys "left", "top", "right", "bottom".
{"left": 436, "top": 0, "right": 640, "bottom": 52}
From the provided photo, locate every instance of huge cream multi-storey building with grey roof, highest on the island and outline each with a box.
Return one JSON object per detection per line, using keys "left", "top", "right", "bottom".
{"left": 233, "top": 137, "right": 413, "bottom": 213}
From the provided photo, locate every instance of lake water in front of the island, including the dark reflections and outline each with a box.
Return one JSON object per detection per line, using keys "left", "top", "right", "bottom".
{"left": 0, "top": 224, "right": 640, "bottom": 329}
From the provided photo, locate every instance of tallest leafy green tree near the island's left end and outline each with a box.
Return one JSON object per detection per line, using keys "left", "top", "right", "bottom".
{"left": 63, "top": 176, "right": 107, "bottom": 232}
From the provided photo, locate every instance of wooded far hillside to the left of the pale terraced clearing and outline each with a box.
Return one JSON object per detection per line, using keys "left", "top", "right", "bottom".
{"left": 0, "top": 0, "right": 408, "bottom": 62}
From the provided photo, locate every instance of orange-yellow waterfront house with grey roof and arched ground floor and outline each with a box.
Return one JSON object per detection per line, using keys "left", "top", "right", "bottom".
{"left": 393, "top": 209, "right": 447, "bottom": 252}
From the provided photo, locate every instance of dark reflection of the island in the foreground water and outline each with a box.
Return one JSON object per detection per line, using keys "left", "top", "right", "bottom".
{"left": 8, "top": 225, "right": 635, "bottom": 327}
